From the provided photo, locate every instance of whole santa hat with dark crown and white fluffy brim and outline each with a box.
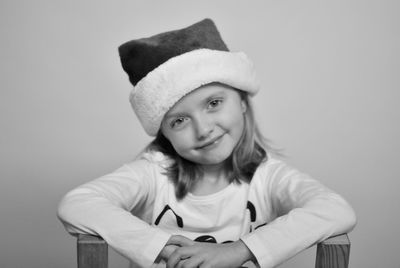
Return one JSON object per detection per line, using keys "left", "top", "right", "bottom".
{"left": 119, "top": 19, "right": 259, "bottom": 136}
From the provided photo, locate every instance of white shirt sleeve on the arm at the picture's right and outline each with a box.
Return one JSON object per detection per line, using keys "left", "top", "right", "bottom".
{"left": 242, "top": 160, "right": 356, "bottom": 267}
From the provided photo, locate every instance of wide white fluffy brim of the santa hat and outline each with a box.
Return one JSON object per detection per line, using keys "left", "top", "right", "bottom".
{"left": 129, "top": 49, "right": 260, "bottom": 136}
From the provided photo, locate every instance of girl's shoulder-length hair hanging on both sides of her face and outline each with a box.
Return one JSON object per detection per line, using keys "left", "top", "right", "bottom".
{"left": 145, "top": 90, "right": 271, "bottom": 200}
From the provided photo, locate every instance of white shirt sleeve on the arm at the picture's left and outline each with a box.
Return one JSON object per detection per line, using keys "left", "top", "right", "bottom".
{"left": 58, "top": 159, "right": 170, "bottom": 267}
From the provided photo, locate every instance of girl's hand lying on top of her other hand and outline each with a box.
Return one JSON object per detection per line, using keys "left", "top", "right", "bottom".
{"left": 167, "top": 240, "right": 254, "bottom": 268}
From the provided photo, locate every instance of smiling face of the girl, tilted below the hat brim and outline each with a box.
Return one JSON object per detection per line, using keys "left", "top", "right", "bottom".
{"left": 161, "top": 83, "right": 246, "bottom": 169}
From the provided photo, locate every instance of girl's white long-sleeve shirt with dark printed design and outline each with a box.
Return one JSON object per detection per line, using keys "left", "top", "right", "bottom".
{"left": 58, "top": 152, "right": 356, "bottom": 267}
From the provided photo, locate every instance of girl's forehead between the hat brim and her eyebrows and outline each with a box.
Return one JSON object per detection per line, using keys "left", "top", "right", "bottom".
{"left": 165, "top": 83, "right": 239, "bottom": 117}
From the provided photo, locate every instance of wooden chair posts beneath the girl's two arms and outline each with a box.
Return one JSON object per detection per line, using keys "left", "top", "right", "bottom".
{"left": 78, "top": 234, "right": 350, "bottom": 268}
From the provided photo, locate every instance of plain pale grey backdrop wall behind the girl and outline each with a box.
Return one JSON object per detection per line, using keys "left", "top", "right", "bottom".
{"left": 0, "top": 0, "right": 400, "bottom": 268}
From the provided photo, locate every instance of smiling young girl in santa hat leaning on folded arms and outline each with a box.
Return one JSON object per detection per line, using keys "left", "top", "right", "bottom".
{"left": 58, "top": 19, "right": 355, "bottom": 268}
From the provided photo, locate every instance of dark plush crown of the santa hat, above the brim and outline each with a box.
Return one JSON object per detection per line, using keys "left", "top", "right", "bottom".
{"left": 119, "top": 19, "right": 229, "bottom": 86}
